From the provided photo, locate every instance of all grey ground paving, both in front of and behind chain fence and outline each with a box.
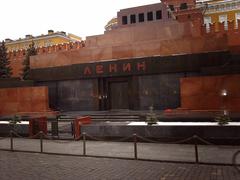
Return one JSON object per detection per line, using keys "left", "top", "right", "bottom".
{"left": 0, "top": 138, "right": 240, "bottom": 180}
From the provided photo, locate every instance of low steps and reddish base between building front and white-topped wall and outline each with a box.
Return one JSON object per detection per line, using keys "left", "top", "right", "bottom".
{"left": 59, "top": 109, "right": 240, "bottom": 123}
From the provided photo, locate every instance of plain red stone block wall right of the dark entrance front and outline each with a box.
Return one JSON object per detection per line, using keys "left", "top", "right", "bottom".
{"left": 180, "top": 75, "right": 240, "bottom": 111}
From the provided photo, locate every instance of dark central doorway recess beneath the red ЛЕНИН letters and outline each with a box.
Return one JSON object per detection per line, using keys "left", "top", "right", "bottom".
{"left": 98, "top": 76, "right": 139, "bottom": 110}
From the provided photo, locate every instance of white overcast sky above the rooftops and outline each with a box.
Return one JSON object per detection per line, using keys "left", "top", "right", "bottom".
{"left": 0, "top": 0, "right": 160, "bottom": 40}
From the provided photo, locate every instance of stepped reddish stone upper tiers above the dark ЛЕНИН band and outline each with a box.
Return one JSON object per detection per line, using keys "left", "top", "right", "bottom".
{"left": 30, "top": 21, "right": 231, "bottom": 69}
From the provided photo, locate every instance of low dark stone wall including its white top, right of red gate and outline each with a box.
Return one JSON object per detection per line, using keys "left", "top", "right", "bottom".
{"left": 81, "top": 122, "right": 240, "bottom": 145}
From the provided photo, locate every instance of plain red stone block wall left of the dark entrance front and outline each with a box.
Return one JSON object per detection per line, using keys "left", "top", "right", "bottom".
{"left": 0, "top": 87, "right": 49, "bottom": 115}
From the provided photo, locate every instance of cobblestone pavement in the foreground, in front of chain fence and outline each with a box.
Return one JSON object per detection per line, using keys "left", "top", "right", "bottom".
{"left": 0, "top": 151, "right": 240, "bottom": 180}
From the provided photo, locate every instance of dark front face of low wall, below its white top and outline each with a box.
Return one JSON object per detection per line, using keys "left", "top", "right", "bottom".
{"left": 81, "top": 123, "right": 240, "bottom": 139}
